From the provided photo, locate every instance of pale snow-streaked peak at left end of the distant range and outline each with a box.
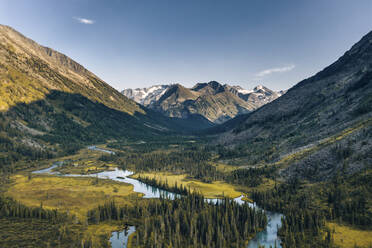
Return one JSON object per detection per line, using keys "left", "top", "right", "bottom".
{"left": 121, "top": 85, "right": 170, "bottom": 106}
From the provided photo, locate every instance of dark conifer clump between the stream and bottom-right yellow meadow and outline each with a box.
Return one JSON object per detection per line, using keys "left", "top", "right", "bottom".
{"left": 252, "top": 178, "right": 333, "bottom": 248}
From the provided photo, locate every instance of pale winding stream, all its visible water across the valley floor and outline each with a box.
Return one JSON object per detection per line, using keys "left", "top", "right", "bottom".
{"left": 32, "top": 146, "right": 283, "bottom": 248}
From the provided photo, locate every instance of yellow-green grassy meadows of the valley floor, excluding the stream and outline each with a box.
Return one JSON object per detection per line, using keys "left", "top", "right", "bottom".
{"left": 0, "top": 142, "right": 372, "bottom": 248}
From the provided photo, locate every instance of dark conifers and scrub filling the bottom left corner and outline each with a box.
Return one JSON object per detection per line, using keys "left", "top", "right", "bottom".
{"left": 0, "top": 195, "right": 85, "bottom": 248}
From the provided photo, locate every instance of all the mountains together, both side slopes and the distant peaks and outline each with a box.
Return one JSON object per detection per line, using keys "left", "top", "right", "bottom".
{"left": 0, "top": 25, "right": 372, "bottom": 183}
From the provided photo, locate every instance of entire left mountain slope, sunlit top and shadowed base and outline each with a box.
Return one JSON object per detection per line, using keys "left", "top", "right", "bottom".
{"left": 0, "top": 25, "right": 181, "bottom": 165}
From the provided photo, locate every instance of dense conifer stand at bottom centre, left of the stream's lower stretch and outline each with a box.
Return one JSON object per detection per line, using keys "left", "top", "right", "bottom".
{"left": 88, "top": 193, "right": 267, "bottom": 247}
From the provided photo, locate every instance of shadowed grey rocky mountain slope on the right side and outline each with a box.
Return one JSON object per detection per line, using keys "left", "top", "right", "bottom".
{"left": 214, "top": 32, "right": 372, "bottom": 180}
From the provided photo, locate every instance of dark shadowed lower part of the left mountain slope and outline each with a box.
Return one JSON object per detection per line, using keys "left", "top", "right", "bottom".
{"left": 0, "top": 90, "right": 190, "bottom": 171}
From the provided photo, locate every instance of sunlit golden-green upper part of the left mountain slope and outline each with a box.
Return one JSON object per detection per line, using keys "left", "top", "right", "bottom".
{"left": 0, "top": 25, "right": 145, "bottom": 114}
